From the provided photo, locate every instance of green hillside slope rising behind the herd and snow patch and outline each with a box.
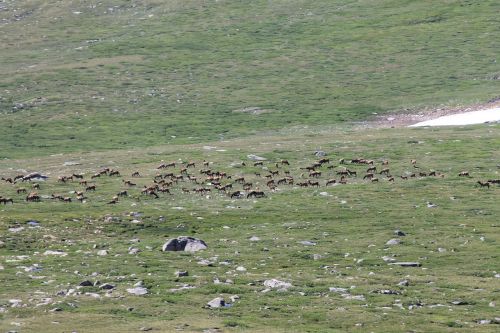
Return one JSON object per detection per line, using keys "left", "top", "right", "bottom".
{"left": 0, "top": 0, "right": 500, "bottom": 158}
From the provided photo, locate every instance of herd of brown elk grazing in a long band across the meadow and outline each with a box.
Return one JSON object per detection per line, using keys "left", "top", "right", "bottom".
{"left": 0, "top": 158, "right": 500, "bottom": 205}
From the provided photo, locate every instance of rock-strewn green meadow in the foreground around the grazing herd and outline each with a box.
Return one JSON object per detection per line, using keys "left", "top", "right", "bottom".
{"left": 0, "top": 125, "right": 500, "bottom": 332}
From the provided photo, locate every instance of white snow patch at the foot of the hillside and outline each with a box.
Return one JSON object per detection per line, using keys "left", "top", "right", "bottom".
{"left": 409, "top": 107, "right": 500, "bottom": 127}
